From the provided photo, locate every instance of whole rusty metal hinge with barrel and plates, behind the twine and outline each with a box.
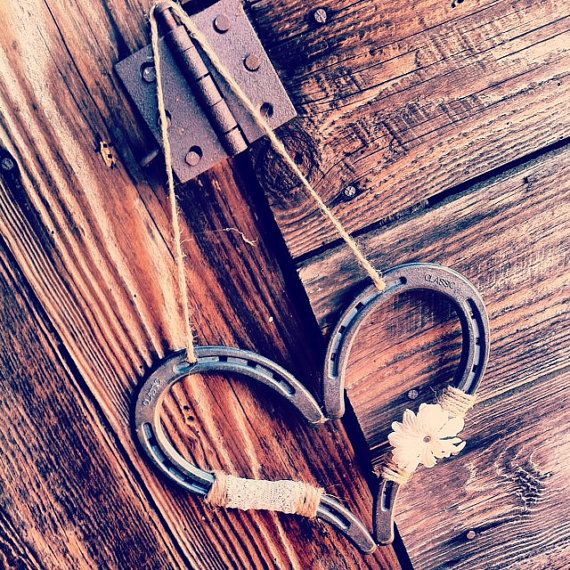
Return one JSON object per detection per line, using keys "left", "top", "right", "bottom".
{"left": 115, "top": 0, "right": 296, "bottom": 182}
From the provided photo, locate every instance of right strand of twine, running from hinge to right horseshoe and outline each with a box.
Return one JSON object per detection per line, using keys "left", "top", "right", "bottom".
{"left": 151, "top": 0, "right": 386, "bottom": 291}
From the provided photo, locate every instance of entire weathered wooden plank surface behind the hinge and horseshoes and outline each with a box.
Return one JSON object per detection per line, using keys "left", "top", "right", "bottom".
{"left": 0, "top": 0, "right": 570, "bottom": 569}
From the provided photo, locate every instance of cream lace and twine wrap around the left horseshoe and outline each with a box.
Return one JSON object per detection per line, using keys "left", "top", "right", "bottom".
{"left": 205, "top": 471, "right": 324, "bottom": 519}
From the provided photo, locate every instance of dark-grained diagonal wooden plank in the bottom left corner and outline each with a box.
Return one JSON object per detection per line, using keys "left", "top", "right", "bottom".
{"left": 0, "top": 243, "right": 182, "bottom": 568}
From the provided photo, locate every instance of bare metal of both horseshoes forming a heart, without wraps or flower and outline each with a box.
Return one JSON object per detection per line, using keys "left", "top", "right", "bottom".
{"left": 133, "top": 263, "right": 489, "bottom": 552}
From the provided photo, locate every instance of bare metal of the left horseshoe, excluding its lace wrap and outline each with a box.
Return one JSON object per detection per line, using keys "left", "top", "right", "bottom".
{"left": 133, "top": 346, "right": 376, "bottom": 553}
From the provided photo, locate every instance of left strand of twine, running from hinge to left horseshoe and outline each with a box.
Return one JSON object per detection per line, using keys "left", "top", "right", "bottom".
{"left": 149, "top": 4, "right": 197, "bottom": 364}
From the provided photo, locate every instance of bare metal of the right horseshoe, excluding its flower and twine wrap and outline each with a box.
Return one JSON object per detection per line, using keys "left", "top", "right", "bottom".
{"left": 323, "top": 263, "right": 490, "bottom": 544}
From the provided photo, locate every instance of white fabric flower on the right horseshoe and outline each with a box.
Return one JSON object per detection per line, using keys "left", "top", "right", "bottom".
{"left": 388, "top": 404, "right": 465, "bottom": 472}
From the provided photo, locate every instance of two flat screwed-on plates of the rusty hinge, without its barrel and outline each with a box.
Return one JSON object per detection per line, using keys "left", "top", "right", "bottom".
{"left": 115, "top": 0, "right": 296, "bottom": 182}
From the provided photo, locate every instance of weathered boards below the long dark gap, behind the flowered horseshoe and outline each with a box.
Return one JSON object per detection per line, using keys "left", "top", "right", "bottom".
{"left": 300, "top": 145, "right": 570, "bottom": 569}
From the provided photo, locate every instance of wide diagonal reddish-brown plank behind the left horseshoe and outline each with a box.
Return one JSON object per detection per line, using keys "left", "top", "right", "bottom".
{"left": 0, "top": 1, "right": 398, "bottom": 569}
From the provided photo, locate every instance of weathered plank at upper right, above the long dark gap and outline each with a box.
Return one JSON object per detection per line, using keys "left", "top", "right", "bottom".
{"left": 250, "top": 0, "right": 570, "bottom": 258}
